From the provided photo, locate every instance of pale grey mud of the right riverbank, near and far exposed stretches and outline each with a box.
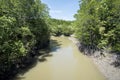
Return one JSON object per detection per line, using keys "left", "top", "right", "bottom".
{"left": 69, "top": 36, "right": 120, "bottom": 80}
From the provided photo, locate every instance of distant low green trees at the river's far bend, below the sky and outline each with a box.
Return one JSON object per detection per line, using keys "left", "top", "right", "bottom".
{"left": 50, "top": 18, "right": 74, "bottom": 36}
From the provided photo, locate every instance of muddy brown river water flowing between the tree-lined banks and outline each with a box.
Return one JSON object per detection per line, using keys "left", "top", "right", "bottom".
{"left": 15, "top": 37, "right": 105, "bottom": 80}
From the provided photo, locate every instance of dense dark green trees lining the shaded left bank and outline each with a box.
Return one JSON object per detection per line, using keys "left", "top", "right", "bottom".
{"left": 0, "top": 0, "right": 50, "bottom": 80}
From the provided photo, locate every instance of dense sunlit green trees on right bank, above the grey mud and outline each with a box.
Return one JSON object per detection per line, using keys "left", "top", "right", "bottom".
{"left": 74, "top": 0, "right": 120, "bottom": 54}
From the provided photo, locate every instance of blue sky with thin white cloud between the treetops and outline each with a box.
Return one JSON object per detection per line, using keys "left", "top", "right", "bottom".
{"left": 41, "top": 0, "right": 79, "bottom": 20}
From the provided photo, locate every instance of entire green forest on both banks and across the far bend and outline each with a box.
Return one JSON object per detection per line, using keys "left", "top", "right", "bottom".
{"left": 0, "top": 0, "right": 120, "bottom": 80}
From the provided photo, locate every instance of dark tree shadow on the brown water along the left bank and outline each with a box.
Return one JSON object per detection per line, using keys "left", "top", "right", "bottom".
{"left": 10, "top": 39, "right": 61, "bottom": 80}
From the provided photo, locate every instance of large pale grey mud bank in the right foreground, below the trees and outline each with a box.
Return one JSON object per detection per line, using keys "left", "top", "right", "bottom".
{"left": 91, "top": 52, "right": 120, "bottom": 80}
